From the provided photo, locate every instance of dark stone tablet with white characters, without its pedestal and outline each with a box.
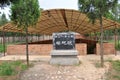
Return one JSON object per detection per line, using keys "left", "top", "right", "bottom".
{"left": 53, "top": 33, "right": 75, "bottom": 50}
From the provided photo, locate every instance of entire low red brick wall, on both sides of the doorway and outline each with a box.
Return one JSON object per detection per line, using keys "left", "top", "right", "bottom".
{"left": 7, "top": 43, "right": 115, "bottom": 55}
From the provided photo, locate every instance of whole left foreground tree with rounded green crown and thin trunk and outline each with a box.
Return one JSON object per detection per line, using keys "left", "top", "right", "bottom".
{"left": 11, "top": 0, "right": 40, "bottom": 65}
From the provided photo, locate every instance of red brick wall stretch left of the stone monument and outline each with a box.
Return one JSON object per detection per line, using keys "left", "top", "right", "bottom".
{"left": 7, "top": 44, "right": 52, "bottom": 55}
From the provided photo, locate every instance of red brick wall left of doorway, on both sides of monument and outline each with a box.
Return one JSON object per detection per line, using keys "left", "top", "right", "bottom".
{"left": 7, "top": 44, "right": 87, "bottom": 55}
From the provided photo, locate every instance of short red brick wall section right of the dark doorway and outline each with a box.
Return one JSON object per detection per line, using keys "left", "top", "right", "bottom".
{"left": 96, "top": 43, "right": 115, "bottom": 55}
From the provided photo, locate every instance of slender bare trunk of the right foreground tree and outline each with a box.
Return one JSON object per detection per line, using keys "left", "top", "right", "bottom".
{"left": 100, "top": 16, "right": 104, "bottom": 67}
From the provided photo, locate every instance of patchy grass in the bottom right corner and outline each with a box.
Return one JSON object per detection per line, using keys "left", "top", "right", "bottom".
{"left": 106, "top": 60, "right": 120, "bottom": 80}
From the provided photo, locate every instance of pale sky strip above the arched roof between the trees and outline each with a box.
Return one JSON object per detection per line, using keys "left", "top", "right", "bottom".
{"left": 39, "top": 0, "right": 78, "bottom": 10}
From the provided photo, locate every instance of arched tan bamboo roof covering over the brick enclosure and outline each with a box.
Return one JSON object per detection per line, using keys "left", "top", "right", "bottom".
{"left": 0, "top": 9, "right": 120, "bottom": 35}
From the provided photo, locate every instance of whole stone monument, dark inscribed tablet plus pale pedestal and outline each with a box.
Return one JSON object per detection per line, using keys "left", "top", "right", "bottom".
{"left": 50, "top": 32, "right": 79, "bottom": 65}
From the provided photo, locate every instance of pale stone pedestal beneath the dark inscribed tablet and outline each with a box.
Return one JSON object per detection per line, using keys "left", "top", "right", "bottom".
{"left": 50, "top": 50, "right": 79, "bottom": 65}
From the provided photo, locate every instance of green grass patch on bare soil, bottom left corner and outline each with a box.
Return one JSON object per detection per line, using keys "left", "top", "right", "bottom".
{"left": 0, "top": 61, "right": 28, "bottom": 80}
